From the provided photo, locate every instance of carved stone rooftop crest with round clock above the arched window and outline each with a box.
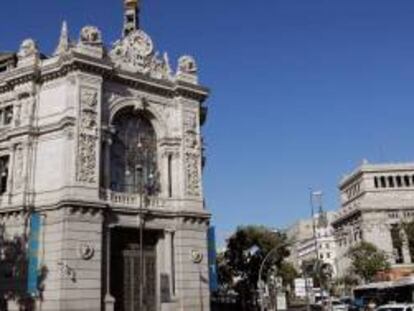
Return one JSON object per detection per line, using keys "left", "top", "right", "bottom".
{"left": 109, "top": 29, "right": 172, "bottom": 79}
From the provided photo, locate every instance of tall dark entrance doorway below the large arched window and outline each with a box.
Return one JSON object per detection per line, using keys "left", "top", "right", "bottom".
{"left": 111, "top": 228, "right": 158, "bottom": 311}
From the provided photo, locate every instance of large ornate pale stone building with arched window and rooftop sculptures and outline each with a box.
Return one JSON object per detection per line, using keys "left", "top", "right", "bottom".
{"left": 0, "top": 0, "right": 210, "bottom": 311}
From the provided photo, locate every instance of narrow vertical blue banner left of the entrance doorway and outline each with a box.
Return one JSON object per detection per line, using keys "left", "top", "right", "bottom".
{"left": 27, "top": 213, "right": 41, "bottom": 295}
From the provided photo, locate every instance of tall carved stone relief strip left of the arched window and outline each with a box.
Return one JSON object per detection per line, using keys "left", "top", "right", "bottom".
{"left": 76, "top": 88, "right": 98, "bottom": 184}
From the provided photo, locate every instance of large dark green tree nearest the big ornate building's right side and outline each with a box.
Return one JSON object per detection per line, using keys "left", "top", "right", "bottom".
{"left": 218, "top": 226, "right": 291, "bottom": 310}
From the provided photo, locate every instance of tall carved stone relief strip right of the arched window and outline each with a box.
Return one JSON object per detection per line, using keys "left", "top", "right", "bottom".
{"left": 184, "top": 111, "right": 201, "bottom": 196}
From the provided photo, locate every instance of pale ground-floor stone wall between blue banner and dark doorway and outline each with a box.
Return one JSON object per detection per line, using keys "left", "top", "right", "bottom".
{"left": 40, "top": 208, "right": 102, "bottom": 311}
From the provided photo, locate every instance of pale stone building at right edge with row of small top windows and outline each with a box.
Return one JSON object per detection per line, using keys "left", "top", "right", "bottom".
{"left": 333, "top": 162, "right": 414, "bottom": 276}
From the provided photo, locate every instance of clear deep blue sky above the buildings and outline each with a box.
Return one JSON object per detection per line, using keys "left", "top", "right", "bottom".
{"left": 0, "top": 0, "right": 414, "bottom": 247}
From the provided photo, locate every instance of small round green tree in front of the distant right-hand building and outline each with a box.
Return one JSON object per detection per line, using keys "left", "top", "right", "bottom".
{"left": 347, "top": 242, "right": 390, "bottom": 282}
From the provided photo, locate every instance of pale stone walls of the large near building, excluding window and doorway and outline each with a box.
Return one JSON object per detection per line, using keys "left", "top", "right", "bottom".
{"left": 0, "top": 17, "right": 210, "bottom": 311}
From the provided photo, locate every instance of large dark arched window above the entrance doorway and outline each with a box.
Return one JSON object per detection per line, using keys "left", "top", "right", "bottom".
{"left": 111, "top": 108, "right": 159, "bottom": 194}
